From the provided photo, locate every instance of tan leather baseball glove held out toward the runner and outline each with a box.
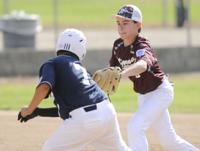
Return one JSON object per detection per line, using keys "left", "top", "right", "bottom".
{"left": 92, "top": 67, "right": 121, "bottom": 95}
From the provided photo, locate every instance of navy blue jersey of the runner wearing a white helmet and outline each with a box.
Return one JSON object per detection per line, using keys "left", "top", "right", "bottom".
{"left": 39, "top": 55, "right": 107, "bottom": 118}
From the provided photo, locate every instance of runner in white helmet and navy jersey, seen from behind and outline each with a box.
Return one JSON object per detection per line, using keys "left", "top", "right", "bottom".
{"left": 18, "top": 29, "right": 130, "bottom": 151}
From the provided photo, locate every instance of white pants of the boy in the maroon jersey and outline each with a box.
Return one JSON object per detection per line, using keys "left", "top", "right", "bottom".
{"left": 128, "top": 79, "right": 199, "bottom": 151}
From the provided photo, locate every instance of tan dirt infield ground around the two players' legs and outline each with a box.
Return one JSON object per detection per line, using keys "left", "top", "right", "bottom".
{"left": 0, "top": 111, "right": 200, "bottom": 151}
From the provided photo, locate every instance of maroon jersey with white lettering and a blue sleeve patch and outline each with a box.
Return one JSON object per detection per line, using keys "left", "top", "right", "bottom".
{"left": 110, "top": 36, "right": 164, "bottom": 94}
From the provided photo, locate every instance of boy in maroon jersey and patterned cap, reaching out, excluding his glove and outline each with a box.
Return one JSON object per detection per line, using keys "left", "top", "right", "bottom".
{"left": 110, "top": 5, "right": 199, "bottom": 151}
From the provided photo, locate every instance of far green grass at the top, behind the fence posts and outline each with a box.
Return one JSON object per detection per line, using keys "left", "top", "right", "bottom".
{"left": 0, "top": 0, "right": 200, "bottom": 27}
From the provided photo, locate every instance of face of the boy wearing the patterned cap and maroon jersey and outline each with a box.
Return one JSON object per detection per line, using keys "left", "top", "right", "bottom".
{"left": 116, "top": 17, "right": 141, "bottom": 40}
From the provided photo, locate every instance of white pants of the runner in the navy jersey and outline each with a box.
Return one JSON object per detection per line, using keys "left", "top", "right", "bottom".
{"left": 43, "top": 100, "right": 130, "bottom": 151}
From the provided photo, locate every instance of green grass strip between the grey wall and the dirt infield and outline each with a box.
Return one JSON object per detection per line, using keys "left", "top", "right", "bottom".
{"left": 0, "top": 77, "right": 200, "bottom": 113}
